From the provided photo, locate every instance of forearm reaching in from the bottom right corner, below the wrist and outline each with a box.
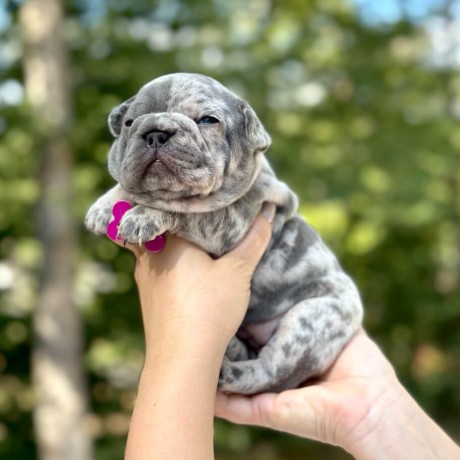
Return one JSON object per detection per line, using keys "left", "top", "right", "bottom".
{"left": 344, "top": 384, "right": 460, "bottom": 460}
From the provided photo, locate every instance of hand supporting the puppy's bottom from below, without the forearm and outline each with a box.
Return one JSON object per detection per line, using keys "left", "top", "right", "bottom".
{"left": 215, "top": 330, "right": 399, "bottom": 450}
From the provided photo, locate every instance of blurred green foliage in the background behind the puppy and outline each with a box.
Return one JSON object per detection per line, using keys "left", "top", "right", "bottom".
{"left": 0, "top": 0, "right": 460, "bottom": 460}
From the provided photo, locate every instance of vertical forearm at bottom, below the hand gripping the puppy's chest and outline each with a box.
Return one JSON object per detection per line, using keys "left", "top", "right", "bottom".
{"left": 125, "top": 356, "right": 220, "bottom": 460}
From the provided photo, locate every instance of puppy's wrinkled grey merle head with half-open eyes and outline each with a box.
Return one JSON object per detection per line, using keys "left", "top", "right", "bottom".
{"left": 109, "top": 74, "right": 270, "bottom": 207}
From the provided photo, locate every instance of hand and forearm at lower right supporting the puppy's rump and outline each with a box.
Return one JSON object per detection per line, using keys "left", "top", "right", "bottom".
{"left": 216, "top": 330, "right": 460, "bottom": 460}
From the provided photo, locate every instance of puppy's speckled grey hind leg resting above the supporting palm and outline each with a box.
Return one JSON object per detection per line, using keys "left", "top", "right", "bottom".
{"left": 219, "top": 280, "right": 362, "bottom": 394}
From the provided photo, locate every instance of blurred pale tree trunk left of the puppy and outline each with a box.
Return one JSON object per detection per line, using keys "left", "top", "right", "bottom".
{"left": 20, "top": 0, "right": 92, "bottom": 460}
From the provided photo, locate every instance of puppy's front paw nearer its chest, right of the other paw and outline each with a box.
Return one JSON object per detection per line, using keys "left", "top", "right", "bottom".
{"left": 118, "top": 205, "right": 164, "bottom": 244}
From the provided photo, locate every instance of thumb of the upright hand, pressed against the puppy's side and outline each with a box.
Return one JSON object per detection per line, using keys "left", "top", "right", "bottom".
{"left": 224, "top": 203, "right": 276, "bottom": 268}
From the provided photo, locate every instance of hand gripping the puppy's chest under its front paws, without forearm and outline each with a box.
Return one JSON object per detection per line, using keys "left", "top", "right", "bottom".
{"left": 113, "top": 205, "right": 274, "bottom": 360}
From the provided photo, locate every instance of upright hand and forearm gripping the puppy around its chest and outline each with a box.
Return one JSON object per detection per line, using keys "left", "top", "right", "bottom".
{"left": 125, "top": 206, "right": 273, "bottom": 460}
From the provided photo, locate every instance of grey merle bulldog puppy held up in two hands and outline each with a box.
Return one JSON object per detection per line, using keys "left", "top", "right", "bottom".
{"left": 85, "top": 73, "right": 362, "bottom": 394}
